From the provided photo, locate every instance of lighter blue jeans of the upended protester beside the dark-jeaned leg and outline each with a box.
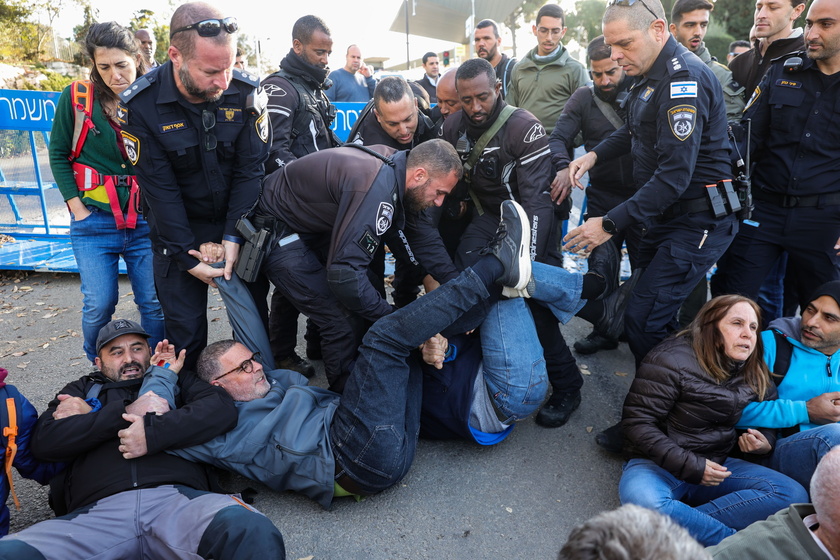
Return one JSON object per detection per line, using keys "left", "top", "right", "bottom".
{"left": 481, "top": 262, "right": 583, "bottom": 420}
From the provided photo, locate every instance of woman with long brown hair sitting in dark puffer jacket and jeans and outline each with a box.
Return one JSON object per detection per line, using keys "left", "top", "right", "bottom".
{"left": 619, "top": 295, "right": 808, "bottom": 546}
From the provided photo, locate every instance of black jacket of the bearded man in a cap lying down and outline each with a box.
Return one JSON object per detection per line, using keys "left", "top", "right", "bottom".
{"left": 32, "top": 372, "right": 237, "bottom": 511}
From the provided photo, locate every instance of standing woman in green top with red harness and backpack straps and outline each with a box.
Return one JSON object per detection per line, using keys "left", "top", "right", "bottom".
{"left": 50, "top": 21, "right": 164, "bottom": 362}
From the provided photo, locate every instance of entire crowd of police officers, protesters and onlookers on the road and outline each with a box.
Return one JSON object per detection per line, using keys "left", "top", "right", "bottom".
{"left": 0, "top": 0, "right": 840, "bottom": 559}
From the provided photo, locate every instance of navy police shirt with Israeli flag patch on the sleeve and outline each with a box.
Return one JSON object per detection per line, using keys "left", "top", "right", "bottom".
{"left": 593, "top": 37, "right": 732, "bottom": 230}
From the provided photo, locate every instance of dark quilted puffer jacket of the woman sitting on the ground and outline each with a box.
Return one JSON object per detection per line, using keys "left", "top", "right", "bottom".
{"left": 621, "top": 337, "right": 777, "bottom": 484}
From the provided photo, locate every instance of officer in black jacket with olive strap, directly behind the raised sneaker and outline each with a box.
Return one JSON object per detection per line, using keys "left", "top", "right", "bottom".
{"left": 442, "top": 58, "right": 583, "bottom": 427}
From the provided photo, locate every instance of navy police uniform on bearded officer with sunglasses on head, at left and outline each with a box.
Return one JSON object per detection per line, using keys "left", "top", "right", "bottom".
{"left": 118, "top": 61, "right": 271, "bottom": 369}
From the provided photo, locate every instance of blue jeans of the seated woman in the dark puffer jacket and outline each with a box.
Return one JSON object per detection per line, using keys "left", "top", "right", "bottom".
{"left": 618, "top": 458, "right": 808, "bottom": 546}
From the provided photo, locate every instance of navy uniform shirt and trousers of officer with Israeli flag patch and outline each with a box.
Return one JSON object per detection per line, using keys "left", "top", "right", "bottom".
{"left": 593, "top": 37, "right": 738, "bottom": 365}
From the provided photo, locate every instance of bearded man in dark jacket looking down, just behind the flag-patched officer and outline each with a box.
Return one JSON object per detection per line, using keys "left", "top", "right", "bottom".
{"left": 548, "top": 35, "right": 644, "bottom": 354}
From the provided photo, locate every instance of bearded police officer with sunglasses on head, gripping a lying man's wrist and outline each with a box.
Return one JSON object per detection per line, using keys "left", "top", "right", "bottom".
{"left": 119, "top": 2, "right": 271, "bottom": 368}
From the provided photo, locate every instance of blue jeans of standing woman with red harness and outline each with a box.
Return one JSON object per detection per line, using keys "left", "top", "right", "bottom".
{"left": 70, "top": 206, "right": 164, "bottom": 362}
